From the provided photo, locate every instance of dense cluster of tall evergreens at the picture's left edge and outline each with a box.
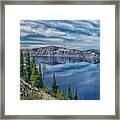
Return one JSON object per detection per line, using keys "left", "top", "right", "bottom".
{"left": 20, "top": 50, "right": 44, "bottom": 88}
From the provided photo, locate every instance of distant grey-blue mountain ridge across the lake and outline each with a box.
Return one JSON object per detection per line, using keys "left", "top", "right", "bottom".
{"left": 22, "top": 46, "right": 100, "bottom": 63}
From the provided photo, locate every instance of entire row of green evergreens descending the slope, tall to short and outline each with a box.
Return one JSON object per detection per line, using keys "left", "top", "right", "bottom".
{"left": 20, "top": 50, "right": 78, "bottom": 100}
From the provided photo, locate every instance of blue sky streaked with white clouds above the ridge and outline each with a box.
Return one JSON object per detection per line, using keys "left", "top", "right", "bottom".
{"left": 20, "top": 20, "right": 100, "bottom": 50}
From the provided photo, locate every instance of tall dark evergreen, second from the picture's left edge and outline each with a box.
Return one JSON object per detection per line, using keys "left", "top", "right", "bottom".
{"left": 25, "top": 50, "right": 30, "bottom": 83}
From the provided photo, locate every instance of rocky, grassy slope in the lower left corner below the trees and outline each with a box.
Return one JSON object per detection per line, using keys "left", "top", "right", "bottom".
{"left": 20, "top": 79, "right": 56, "bottom": 100}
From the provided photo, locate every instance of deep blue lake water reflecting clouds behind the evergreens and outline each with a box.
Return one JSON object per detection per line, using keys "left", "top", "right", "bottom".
{"left": 36, "top": 57, "right": 100, "bottom": 100}
